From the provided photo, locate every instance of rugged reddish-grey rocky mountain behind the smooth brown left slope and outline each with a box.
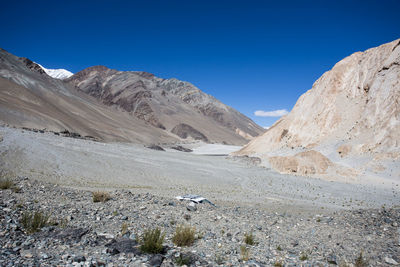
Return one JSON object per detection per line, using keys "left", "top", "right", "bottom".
{"left": 65, "top": 66, "right": 263, "bottom": 144}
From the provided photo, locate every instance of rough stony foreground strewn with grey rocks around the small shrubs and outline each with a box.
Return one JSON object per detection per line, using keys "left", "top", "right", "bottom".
{"left": 0, "top": 177, "right": 400, "bottom": 266}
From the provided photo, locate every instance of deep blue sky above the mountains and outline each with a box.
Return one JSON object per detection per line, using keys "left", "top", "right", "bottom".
{"left": 0, "top": 0, "right": 400, "bottom": 126}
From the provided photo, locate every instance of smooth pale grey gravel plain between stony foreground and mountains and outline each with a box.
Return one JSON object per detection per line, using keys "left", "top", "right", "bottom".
{"left": 0, "top": 127, "right": 400, "bottom": 213}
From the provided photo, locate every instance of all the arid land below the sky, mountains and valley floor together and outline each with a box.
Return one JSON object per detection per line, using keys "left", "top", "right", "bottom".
{"left": 0, "top": 37, "right": 400, "bottom": 267}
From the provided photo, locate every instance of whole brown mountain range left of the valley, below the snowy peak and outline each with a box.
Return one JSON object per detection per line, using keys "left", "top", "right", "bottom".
{"left": 0, "top": 49, "right": 264, "bottom": 145}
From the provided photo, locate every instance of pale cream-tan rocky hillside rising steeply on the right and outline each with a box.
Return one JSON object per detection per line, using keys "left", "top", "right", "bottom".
{"left": 237, "top": 40, "right": 400, "bottom": 182}
